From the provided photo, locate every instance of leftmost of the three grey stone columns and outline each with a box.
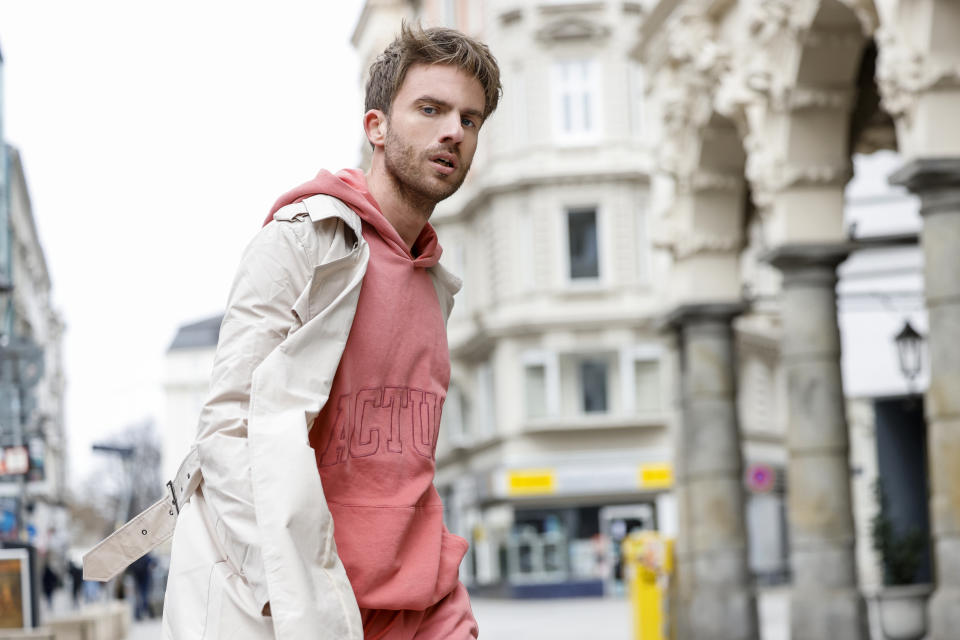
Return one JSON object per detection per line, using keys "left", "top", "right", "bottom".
{"left": 670, "top": 304, "right": 759, "bottom": 640}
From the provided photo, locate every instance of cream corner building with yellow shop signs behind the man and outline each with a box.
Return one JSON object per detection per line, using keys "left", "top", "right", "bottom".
{"left": 354, "top": 2, "right": 688, "bottom": 596}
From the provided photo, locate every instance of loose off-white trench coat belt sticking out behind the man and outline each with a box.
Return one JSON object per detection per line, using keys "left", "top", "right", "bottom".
{"left": 83, "top": 447, "right": 202, "bottom": 582}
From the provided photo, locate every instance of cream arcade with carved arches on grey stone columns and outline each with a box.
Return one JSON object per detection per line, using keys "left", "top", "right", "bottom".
{"left": 634, "top": 0, "right": 960, "bottom": 640}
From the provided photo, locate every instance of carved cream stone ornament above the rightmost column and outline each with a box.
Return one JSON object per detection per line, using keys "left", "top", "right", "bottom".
{"left": 876, "top": 26, "right": 960, "bottom": 118}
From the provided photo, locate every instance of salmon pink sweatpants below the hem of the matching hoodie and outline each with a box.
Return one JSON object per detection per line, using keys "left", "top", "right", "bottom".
{"left": 360, "top": 582, "right": 479, "bottom": 640}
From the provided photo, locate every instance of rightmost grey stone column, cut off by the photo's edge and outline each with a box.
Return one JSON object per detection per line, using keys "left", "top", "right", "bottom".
{"left": 890, "top": 157, "right": 960, "bottom": 640}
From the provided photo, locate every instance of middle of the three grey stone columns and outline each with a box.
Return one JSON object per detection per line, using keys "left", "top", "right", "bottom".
{"left": 766, "top": 244, "right": 868, "bottom": 640}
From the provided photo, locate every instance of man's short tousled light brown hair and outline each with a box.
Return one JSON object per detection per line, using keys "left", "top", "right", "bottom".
{"left": 364, "top": 21, "right": 503, "bottom": 119}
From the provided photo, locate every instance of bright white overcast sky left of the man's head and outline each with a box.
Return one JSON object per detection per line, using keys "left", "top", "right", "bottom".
{"left": 0, "top": 0, "right": 362, "bottom": 480}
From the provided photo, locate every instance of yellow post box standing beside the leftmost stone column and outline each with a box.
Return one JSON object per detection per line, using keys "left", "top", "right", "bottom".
{"left": 622, "top": 531, "right": 673, "bottom": 640}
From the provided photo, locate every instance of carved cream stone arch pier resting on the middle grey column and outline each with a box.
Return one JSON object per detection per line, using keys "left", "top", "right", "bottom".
{"left": 747, "top": 0, "right": 870, "bottom": 247}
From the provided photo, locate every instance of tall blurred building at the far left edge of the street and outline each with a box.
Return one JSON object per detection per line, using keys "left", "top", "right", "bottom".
{"left": 0, "top": 46, "right": 69, "bottom": 557}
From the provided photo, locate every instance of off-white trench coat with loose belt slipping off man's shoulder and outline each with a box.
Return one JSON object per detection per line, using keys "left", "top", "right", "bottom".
{"left": 84, "top": 195, "right": 460, "bottom": 640}
